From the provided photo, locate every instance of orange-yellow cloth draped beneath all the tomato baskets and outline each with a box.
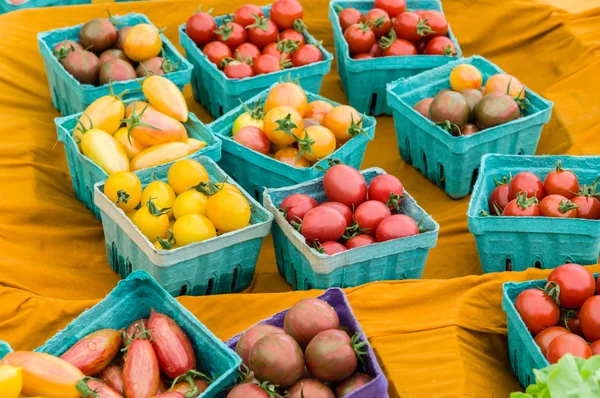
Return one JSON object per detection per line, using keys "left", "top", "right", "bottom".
{"left": 0, "top": 0, "right": 600, "bottom": 397}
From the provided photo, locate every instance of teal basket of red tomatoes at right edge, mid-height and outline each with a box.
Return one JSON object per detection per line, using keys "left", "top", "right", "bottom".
{"left": 467, "top": 155, "right": 600, "bottom": 273}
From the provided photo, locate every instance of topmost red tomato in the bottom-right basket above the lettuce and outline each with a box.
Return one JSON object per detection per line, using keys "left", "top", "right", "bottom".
{"left": 548, "top": 264, "right": 596, "bottom": 308}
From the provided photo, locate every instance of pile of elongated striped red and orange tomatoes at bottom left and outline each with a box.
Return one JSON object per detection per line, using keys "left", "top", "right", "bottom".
{"left": 0, "top": 310, "right": 211, "bottom": 398}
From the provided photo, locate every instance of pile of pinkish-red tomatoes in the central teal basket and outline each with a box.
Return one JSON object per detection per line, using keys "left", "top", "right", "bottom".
{"left": 279, "top": 164, "right": 421, "bottom": 255}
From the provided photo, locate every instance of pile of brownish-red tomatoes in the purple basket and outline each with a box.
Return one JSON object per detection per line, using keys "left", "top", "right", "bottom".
{"left": 227, "top": 298, "right": 373, "bottom": 398}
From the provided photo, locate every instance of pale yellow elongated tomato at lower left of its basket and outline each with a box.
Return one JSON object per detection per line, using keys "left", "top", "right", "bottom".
{"left": 81, "top": 129, "right": 129, "bottom": 175}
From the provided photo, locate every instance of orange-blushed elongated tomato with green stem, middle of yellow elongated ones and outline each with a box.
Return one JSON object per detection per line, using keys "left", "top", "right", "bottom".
{"left": 123, "top": 104, "right": 188, "bottom": 146}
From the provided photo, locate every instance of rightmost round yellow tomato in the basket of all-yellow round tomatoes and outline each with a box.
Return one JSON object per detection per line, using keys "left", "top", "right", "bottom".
{"left": 206, "top": 189, "right": 250, "bottom": 232}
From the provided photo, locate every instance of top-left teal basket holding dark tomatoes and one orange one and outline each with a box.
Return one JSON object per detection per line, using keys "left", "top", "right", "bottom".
{"left": 38, "top": 12, "right": 192, "bottom": 115}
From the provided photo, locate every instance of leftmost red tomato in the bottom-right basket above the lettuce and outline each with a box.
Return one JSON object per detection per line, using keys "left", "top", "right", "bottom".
{"left": 515, "top": 289, "right": 560, "bottom": 336}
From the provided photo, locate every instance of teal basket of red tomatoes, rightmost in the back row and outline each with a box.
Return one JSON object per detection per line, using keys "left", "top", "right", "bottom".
{"left": 329, "top": 0, "right": 462, "bottom": 116}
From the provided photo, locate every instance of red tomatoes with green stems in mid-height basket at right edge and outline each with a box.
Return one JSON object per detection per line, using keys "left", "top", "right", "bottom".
{"left": 488, "top": 161, "right": 600, "bottom": 220}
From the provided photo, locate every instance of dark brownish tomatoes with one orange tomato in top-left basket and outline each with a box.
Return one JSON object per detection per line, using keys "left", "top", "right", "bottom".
{"left": 52, "top": 12, "right": 177, "bottom": 86}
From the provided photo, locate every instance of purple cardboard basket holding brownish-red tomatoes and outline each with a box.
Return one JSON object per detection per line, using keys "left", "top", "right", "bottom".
{"left": 225, "top": 288, "right": 389, "bottom": 398}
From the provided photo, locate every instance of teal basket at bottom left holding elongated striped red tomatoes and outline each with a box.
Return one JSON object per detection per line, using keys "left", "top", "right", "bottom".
{"left": 36, "top": 271, "right": 242, "bottom": 398}
